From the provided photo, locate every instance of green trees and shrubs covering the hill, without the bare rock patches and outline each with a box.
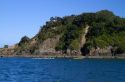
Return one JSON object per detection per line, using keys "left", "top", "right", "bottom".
{"left": 18, "top": 10, "right": 125, "bottom": 53}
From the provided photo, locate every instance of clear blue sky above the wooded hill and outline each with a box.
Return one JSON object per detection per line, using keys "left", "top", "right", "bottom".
{"left": 0, "top": 0, "right": 125, "bottom": 47}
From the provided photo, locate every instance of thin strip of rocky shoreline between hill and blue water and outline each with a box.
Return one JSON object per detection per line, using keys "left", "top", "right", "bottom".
{"left": 0, "top": 55, "right": 125, "bottom": 59}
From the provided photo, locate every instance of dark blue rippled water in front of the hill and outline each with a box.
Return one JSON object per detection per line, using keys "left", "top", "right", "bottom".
{"left": 0, "top": 58, "right": 125, "bottom": 82}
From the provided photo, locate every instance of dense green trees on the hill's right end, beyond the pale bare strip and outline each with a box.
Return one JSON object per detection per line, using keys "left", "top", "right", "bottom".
{"left": 86, "top": 10, "right": 125, "bottom": 52}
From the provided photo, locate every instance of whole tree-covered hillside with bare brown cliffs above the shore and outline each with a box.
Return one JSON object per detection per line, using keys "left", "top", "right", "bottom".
{"left": 1, "top": 10, "right": 125, "bottom": 56}
